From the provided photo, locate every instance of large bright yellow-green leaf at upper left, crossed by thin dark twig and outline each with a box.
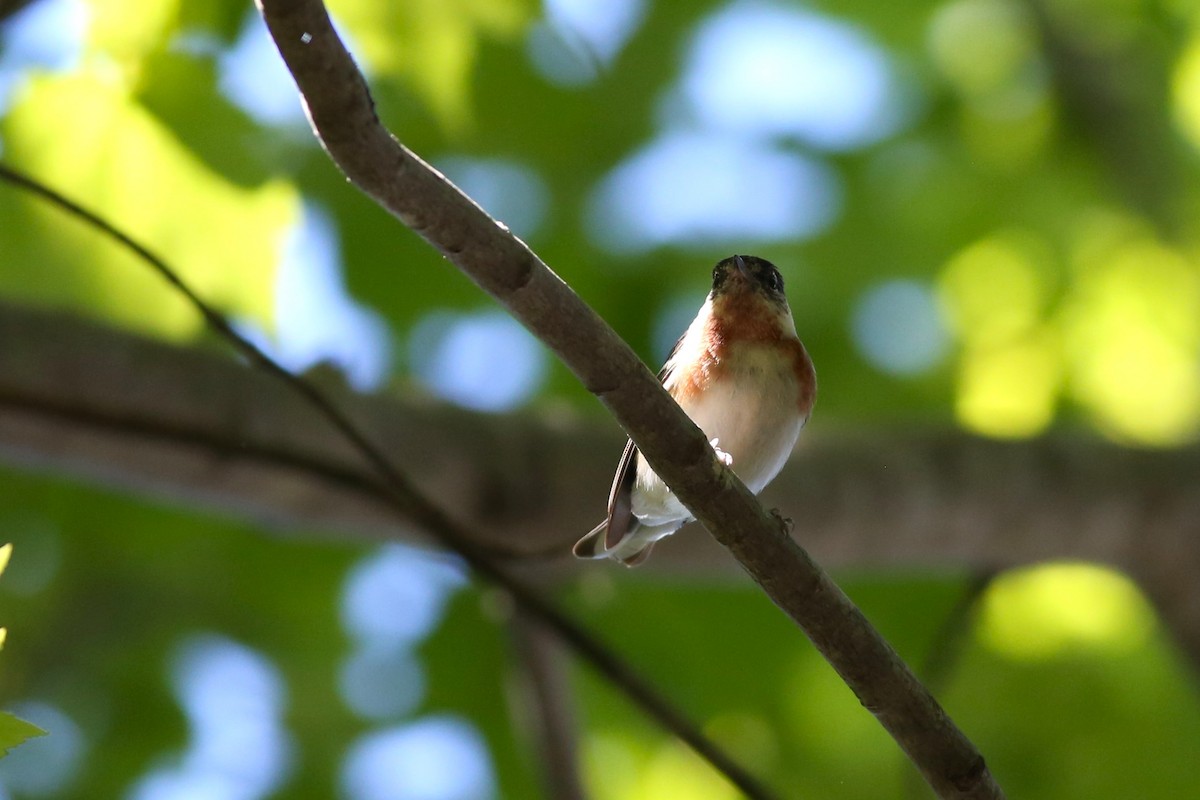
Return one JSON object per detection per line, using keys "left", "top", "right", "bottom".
{"left": 0, "top": 73, "right": 299, "bottom": 336}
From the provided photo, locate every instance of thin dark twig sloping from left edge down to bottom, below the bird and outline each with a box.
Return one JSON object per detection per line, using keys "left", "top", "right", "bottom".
{"left": 0, "top": 164, "right": 774, "bottom": 800}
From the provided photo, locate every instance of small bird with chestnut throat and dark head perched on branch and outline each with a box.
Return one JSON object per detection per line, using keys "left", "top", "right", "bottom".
{"left": 572, "top": 255, "right": 817, "bottom": 566}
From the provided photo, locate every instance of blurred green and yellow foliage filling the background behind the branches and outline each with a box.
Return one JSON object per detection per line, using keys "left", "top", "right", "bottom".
{"left": 0, "top": 0, "right": 1200, "bottom": 800}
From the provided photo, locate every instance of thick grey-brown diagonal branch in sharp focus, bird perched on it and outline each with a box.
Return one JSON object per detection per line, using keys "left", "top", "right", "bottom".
{"left": 258, "top": 0, "right": 1003, "bottom": 799}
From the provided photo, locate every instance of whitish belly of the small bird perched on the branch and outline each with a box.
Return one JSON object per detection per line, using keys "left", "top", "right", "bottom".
{"left": 632, "top": 345, "right": 804, "bottom": 525}
